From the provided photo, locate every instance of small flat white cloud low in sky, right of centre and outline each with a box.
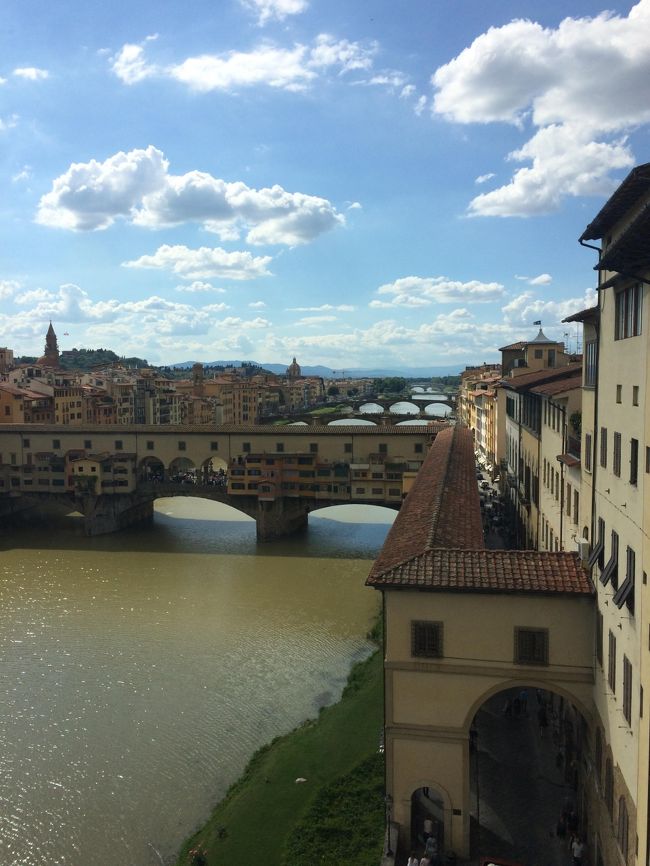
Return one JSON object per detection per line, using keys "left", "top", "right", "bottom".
{"left": 370, "top": 277, "right": 505, "bottom": 309}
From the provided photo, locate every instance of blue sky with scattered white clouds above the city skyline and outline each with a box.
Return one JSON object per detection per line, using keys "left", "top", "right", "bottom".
{"left": 0, "top": 0, "right": 650, "bottom": 370}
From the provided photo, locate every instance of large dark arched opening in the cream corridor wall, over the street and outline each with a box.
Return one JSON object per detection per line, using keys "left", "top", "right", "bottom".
{"left": 469, "top": 686, "right": 588, "bottom": 866}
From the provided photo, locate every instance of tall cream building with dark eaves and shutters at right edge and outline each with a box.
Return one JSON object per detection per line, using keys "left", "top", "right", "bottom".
{"left": 570, "top": 164, "right": 650, "bottom": 864}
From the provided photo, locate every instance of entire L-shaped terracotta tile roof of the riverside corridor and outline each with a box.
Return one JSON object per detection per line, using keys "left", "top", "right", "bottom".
{"left": 366, "top": 427, "right": 594, "bottom": 596}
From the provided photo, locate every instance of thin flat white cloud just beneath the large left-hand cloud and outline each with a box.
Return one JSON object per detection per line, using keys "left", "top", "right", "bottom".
{"left": 122, "top": 244, "right": 271, "bottom": 280}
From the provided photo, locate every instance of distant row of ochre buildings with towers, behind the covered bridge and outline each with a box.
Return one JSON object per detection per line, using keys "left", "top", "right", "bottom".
{"left": 0, "top": 340, "right": 371, "bottom": 427}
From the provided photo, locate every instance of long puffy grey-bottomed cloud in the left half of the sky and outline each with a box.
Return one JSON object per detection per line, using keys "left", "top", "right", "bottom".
{"left": 36, "top": 145, "right": 345, "bottom": 246}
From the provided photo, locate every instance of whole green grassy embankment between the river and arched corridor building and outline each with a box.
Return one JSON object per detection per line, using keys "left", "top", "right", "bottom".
{"left": 177, "top": 624, "right": 384, "bottom": 866}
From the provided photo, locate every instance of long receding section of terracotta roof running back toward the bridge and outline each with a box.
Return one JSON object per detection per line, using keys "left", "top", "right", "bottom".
{"left": 372, "top": 427, "right": 483, "bottom": 574}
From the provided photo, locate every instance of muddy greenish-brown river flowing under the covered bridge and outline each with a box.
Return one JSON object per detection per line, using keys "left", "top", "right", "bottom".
{"left": 0, "top": 499, "right": 395, "bottom": 866}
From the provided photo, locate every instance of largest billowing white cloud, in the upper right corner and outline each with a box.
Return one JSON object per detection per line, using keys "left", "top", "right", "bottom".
{"left": 432, "top": 0, "right": 650, "bottom": 216}
